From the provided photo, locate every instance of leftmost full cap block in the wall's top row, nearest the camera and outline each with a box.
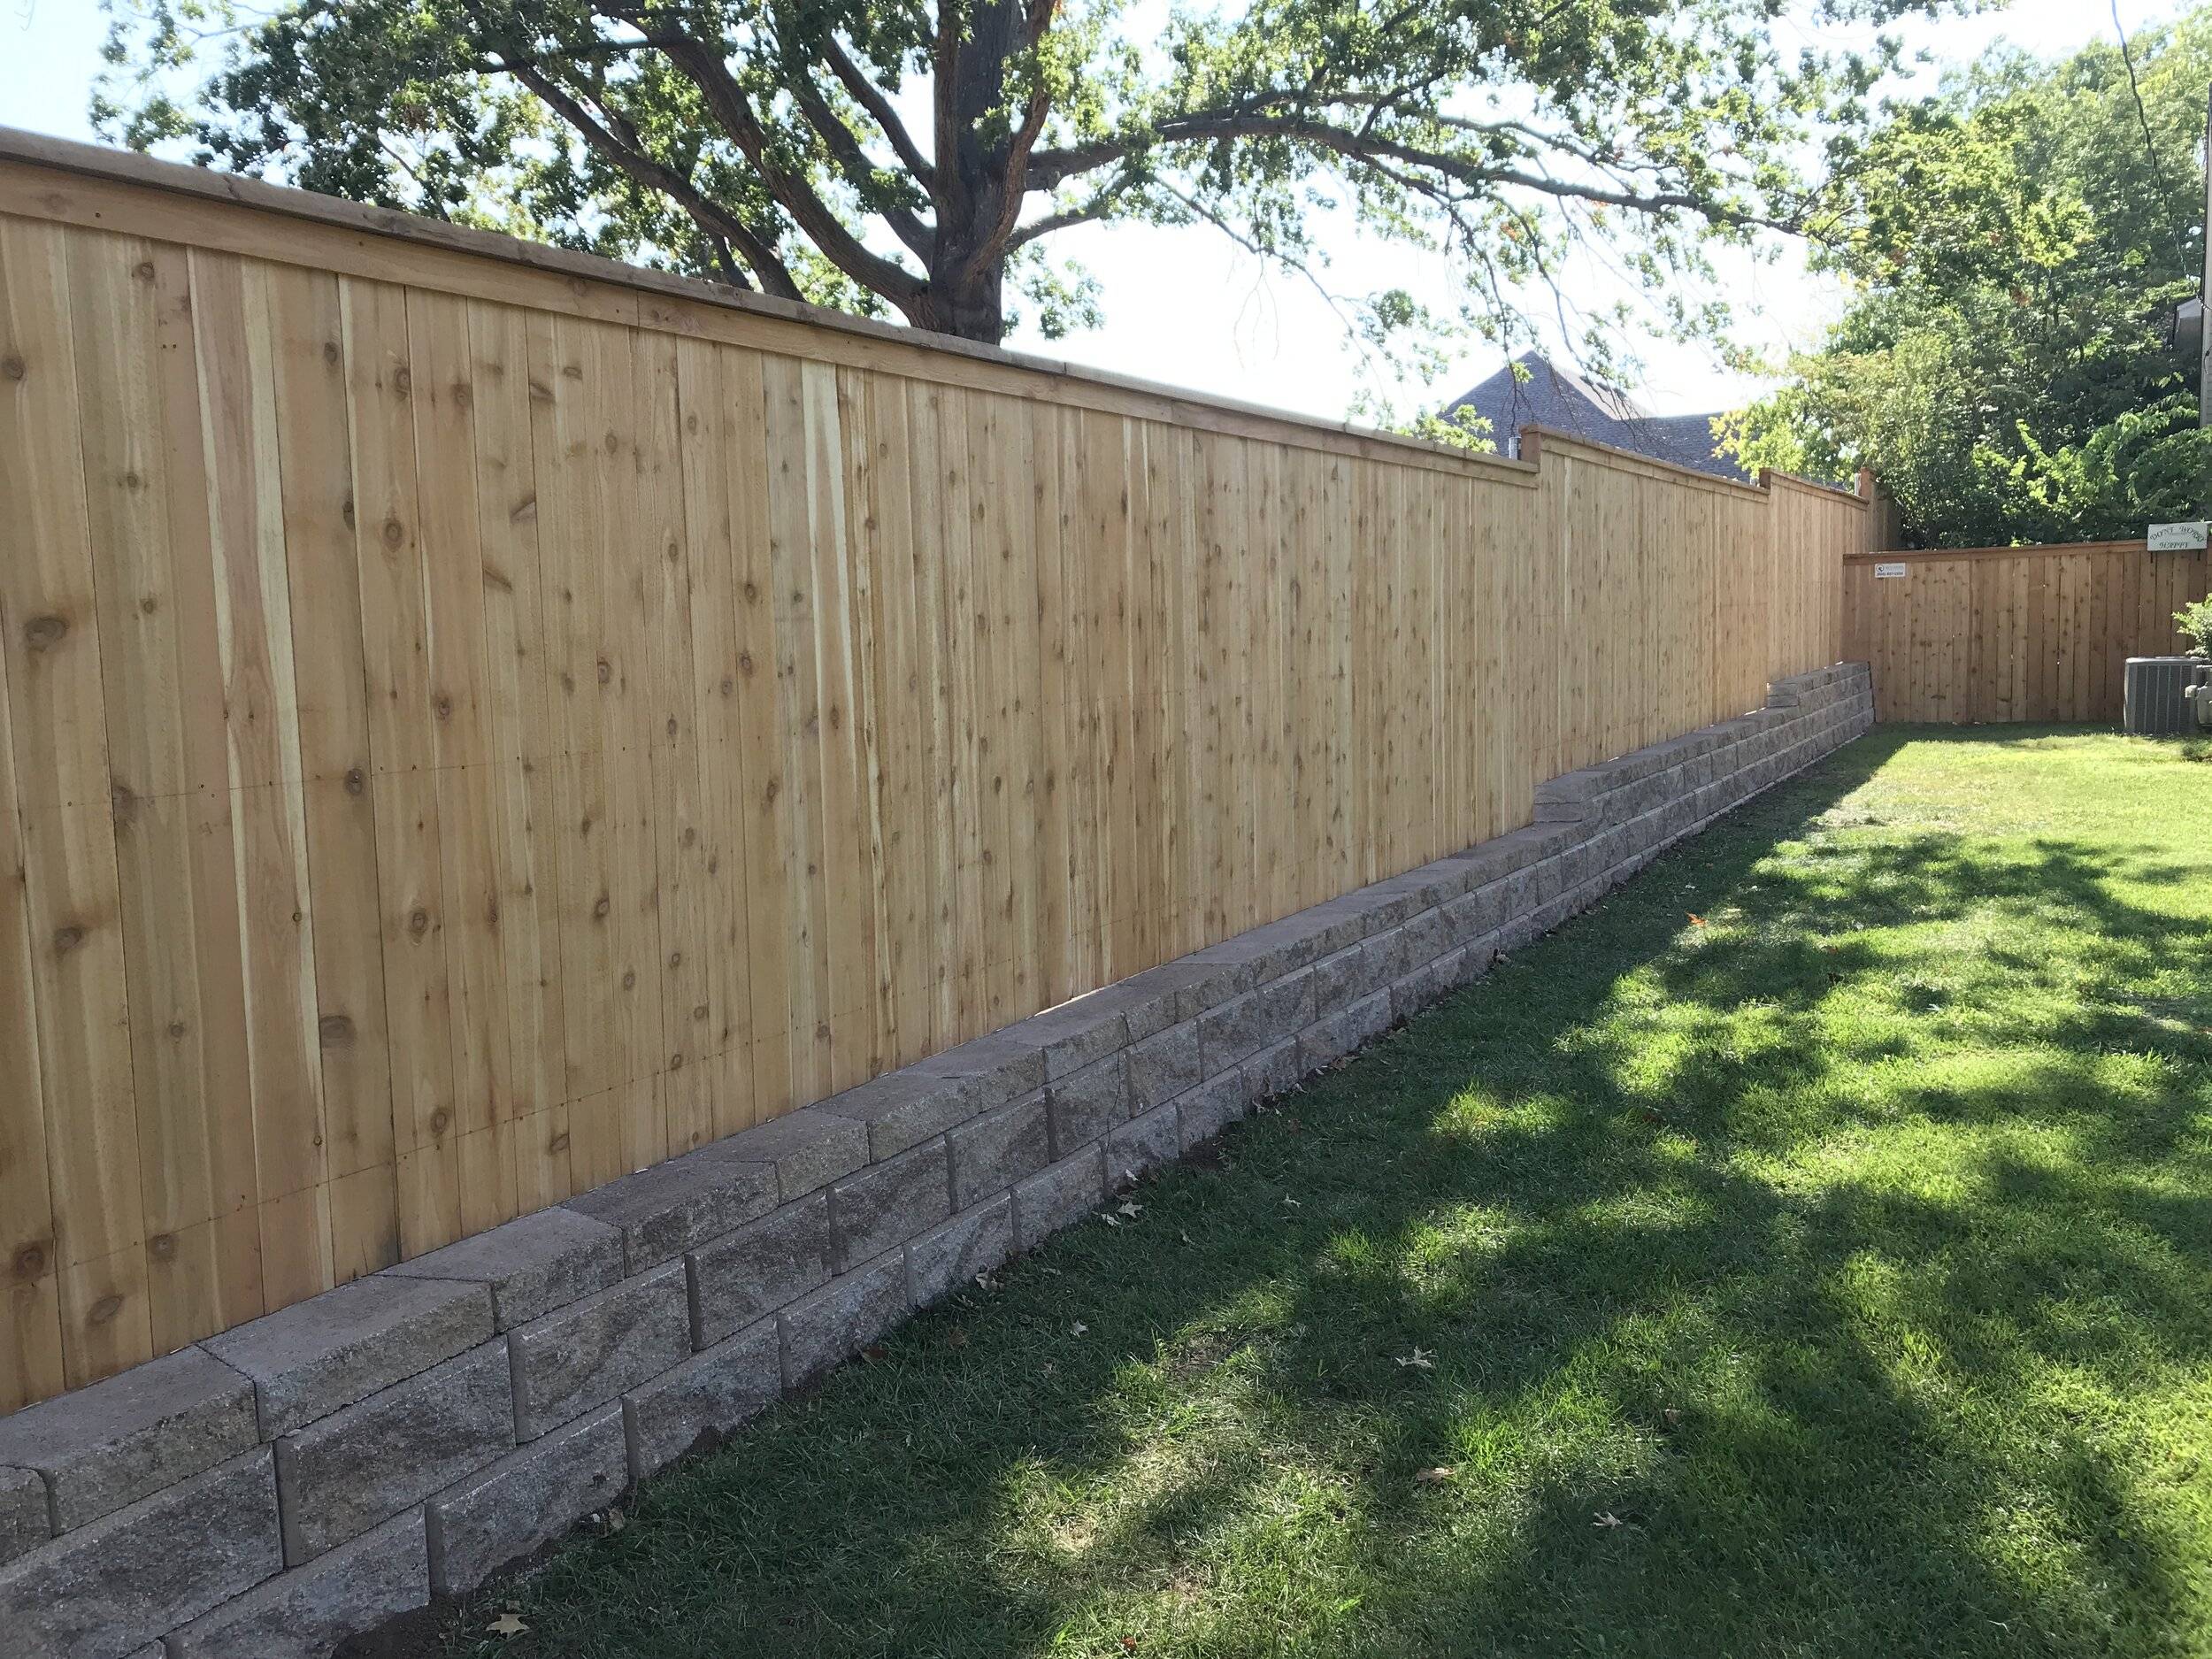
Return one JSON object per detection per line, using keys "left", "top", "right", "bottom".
{"left": 0, "top": 1348, "right": 261, "bottom": 1560}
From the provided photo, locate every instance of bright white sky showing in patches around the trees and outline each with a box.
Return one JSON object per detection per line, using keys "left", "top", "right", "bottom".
{"left": 0, "top": 0, "right": 2177, "bottom": 420}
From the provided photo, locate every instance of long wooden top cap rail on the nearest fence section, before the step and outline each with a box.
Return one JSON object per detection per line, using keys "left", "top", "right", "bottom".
{"left": 0, "top": 127, "right": 1538, "bottom": 485}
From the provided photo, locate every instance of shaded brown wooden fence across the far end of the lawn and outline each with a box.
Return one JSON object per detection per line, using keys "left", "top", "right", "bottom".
{"left": 1843, "top": 542, "right": 2212, "bottom": 726}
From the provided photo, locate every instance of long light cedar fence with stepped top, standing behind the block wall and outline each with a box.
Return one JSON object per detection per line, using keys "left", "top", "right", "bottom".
{"left": 0, "top": 135, "right": 1865, "bottom": 1409}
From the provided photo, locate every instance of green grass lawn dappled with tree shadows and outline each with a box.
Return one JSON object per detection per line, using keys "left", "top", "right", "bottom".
{"left": 431, "top": 728, "right": 2212, "bottom": 1659}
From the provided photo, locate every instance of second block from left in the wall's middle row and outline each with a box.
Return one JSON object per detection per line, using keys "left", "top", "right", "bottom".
{"left": 277, "top": 1340, "right": 516, "bottom": 1566}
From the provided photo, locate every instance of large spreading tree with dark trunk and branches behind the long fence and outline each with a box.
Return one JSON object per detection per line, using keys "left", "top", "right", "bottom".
{"left": 96, "top": 0, "right": 1955, "bottom": 361}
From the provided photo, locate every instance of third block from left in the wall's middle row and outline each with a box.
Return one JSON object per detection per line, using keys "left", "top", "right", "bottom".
{"left": 507, "top": 1261, "right": 693, "bottom": 1440}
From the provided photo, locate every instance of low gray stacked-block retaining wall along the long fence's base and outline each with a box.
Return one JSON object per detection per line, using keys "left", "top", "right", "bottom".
{"left": 0, "top": 666, "right": 1874, "bottom": 1659}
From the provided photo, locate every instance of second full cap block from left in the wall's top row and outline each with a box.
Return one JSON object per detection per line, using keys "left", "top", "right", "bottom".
{"left": 202, "top": 1274, "right": 491, "bottom": 1440}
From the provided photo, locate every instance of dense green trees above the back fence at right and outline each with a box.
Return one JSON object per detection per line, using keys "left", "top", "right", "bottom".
{"left": 1730, "top": 7, "right": 2212, "bottom": 547}
